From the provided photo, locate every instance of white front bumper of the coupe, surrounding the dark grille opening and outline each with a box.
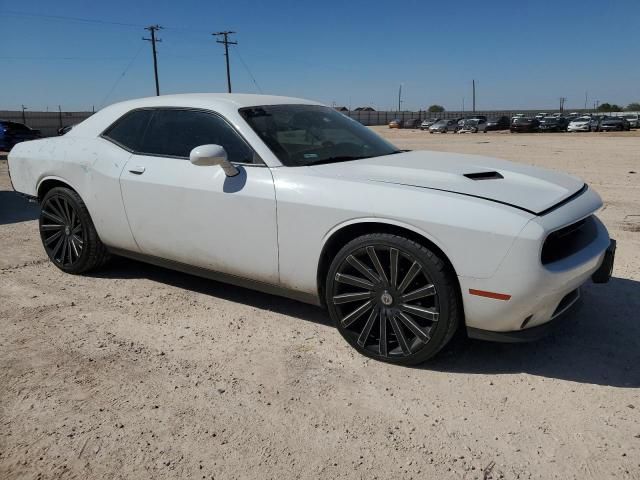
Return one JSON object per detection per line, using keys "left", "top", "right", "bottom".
{"left": 459, "top": 189, "right": 615, "bottom": 335}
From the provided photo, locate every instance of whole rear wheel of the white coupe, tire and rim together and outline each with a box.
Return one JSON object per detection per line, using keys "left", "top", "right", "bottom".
{"left": 39, "top": 187, "right": 109, "bottom": 274}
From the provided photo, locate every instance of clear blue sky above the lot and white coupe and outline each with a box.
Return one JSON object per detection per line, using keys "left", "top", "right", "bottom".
{"left": 0, "top": 0, "right": 640, "bottom": 110}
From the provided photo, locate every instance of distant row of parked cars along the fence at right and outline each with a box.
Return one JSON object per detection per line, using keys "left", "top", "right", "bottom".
{"left": 389, "top": 113, "right": 640, "bottom": 133}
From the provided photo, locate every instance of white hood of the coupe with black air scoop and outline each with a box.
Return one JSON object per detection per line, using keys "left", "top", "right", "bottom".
{"left": 310, "top": 151, "right": 585, "bottom": 215}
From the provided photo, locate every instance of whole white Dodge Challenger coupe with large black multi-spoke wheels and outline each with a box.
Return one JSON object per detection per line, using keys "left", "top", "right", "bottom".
{"left": 9, "top": 94, "right": 615, "bottom": 364}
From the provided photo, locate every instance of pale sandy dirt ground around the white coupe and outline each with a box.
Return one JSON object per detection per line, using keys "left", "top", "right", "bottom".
{"left": 0, "top": 128, "right": 640, "bottom": 479}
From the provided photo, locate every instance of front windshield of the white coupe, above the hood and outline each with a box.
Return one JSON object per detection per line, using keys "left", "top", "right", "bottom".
{"left": 240, "top": 105, "right": 400, "bottom": 167}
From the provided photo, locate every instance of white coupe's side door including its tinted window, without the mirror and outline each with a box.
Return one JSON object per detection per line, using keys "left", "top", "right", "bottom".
{"left": 120, "top": 108, "right": 278, "bottom": 284}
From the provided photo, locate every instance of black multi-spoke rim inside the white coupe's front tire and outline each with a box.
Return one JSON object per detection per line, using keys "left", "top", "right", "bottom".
{"left": 331, "top": 245, "right": 440, "bottom": 357}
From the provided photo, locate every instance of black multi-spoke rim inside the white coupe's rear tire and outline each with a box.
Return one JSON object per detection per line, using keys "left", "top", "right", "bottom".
{"left": 40, "top": 195, "right": 85, "bottom": 267}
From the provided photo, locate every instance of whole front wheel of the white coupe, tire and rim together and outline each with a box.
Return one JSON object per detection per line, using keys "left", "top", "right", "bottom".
{"left": 325, "top": 233, "right": 462, "bottom": 365}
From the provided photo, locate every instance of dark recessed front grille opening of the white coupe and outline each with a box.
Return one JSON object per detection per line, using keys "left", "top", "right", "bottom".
{"left": 541, "top": 216, "right": 598, "bottom": 265}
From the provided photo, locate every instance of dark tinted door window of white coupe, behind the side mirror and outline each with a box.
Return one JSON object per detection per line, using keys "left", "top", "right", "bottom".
{"left": 139, "top": 108, "right": 255, "bottom": 163}
